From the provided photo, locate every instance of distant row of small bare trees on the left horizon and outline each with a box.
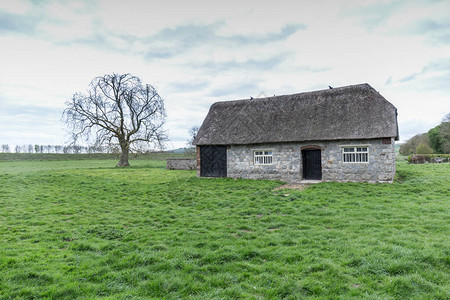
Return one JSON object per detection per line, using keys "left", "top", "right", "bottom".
{"left": 0, "top": 144, "right": 120, "bottom": 154}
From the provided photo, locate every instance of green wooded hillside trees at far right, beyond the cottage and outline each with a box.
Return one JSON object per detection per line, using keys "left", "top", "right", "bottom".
{"left": 399, "top": 113, "right": 450, "bottom": 155}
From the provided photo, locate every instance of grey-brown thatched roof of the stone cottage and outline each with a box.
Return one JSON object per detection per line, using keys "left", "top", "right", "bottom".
{"left": 193, "top": 84, "right": 398, "bottom": 145}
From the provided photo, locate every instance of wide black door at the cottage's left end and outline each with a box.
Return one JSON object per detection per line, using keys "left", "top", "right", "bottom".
{"left": 200, "top": 146, "right": 227, "bottom": 177}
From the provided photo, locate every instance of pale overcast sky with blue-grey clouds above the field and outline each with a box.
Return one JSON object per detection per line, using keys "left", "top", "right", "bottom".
{"left": 0, "top": 0, "right": 450, "bottom": 148}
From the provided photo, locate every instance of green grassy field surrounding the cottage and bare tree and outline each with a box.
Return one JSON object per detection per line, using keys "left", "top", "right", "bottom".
{"left": 0, "top": 159, "right": 450, "bottom": 299}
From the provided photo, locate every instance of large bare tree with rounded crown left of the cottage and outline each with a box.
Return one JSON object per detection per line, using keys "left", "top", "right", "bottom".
{"left": 63, "top": 74, "right": 167, "bottom": 167}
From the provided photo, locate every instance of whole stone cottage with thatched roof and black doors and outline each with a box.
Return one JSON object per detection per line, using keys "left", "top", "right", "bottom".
{"left": 193, "top": 84, "right": 399, "bottom": 182}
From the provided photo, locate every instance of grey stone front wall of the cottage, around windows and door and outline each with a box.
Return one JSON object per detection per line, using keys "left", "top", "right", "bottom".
{"left": 227, "top": 139, "right": 395, "bottom": 182}
